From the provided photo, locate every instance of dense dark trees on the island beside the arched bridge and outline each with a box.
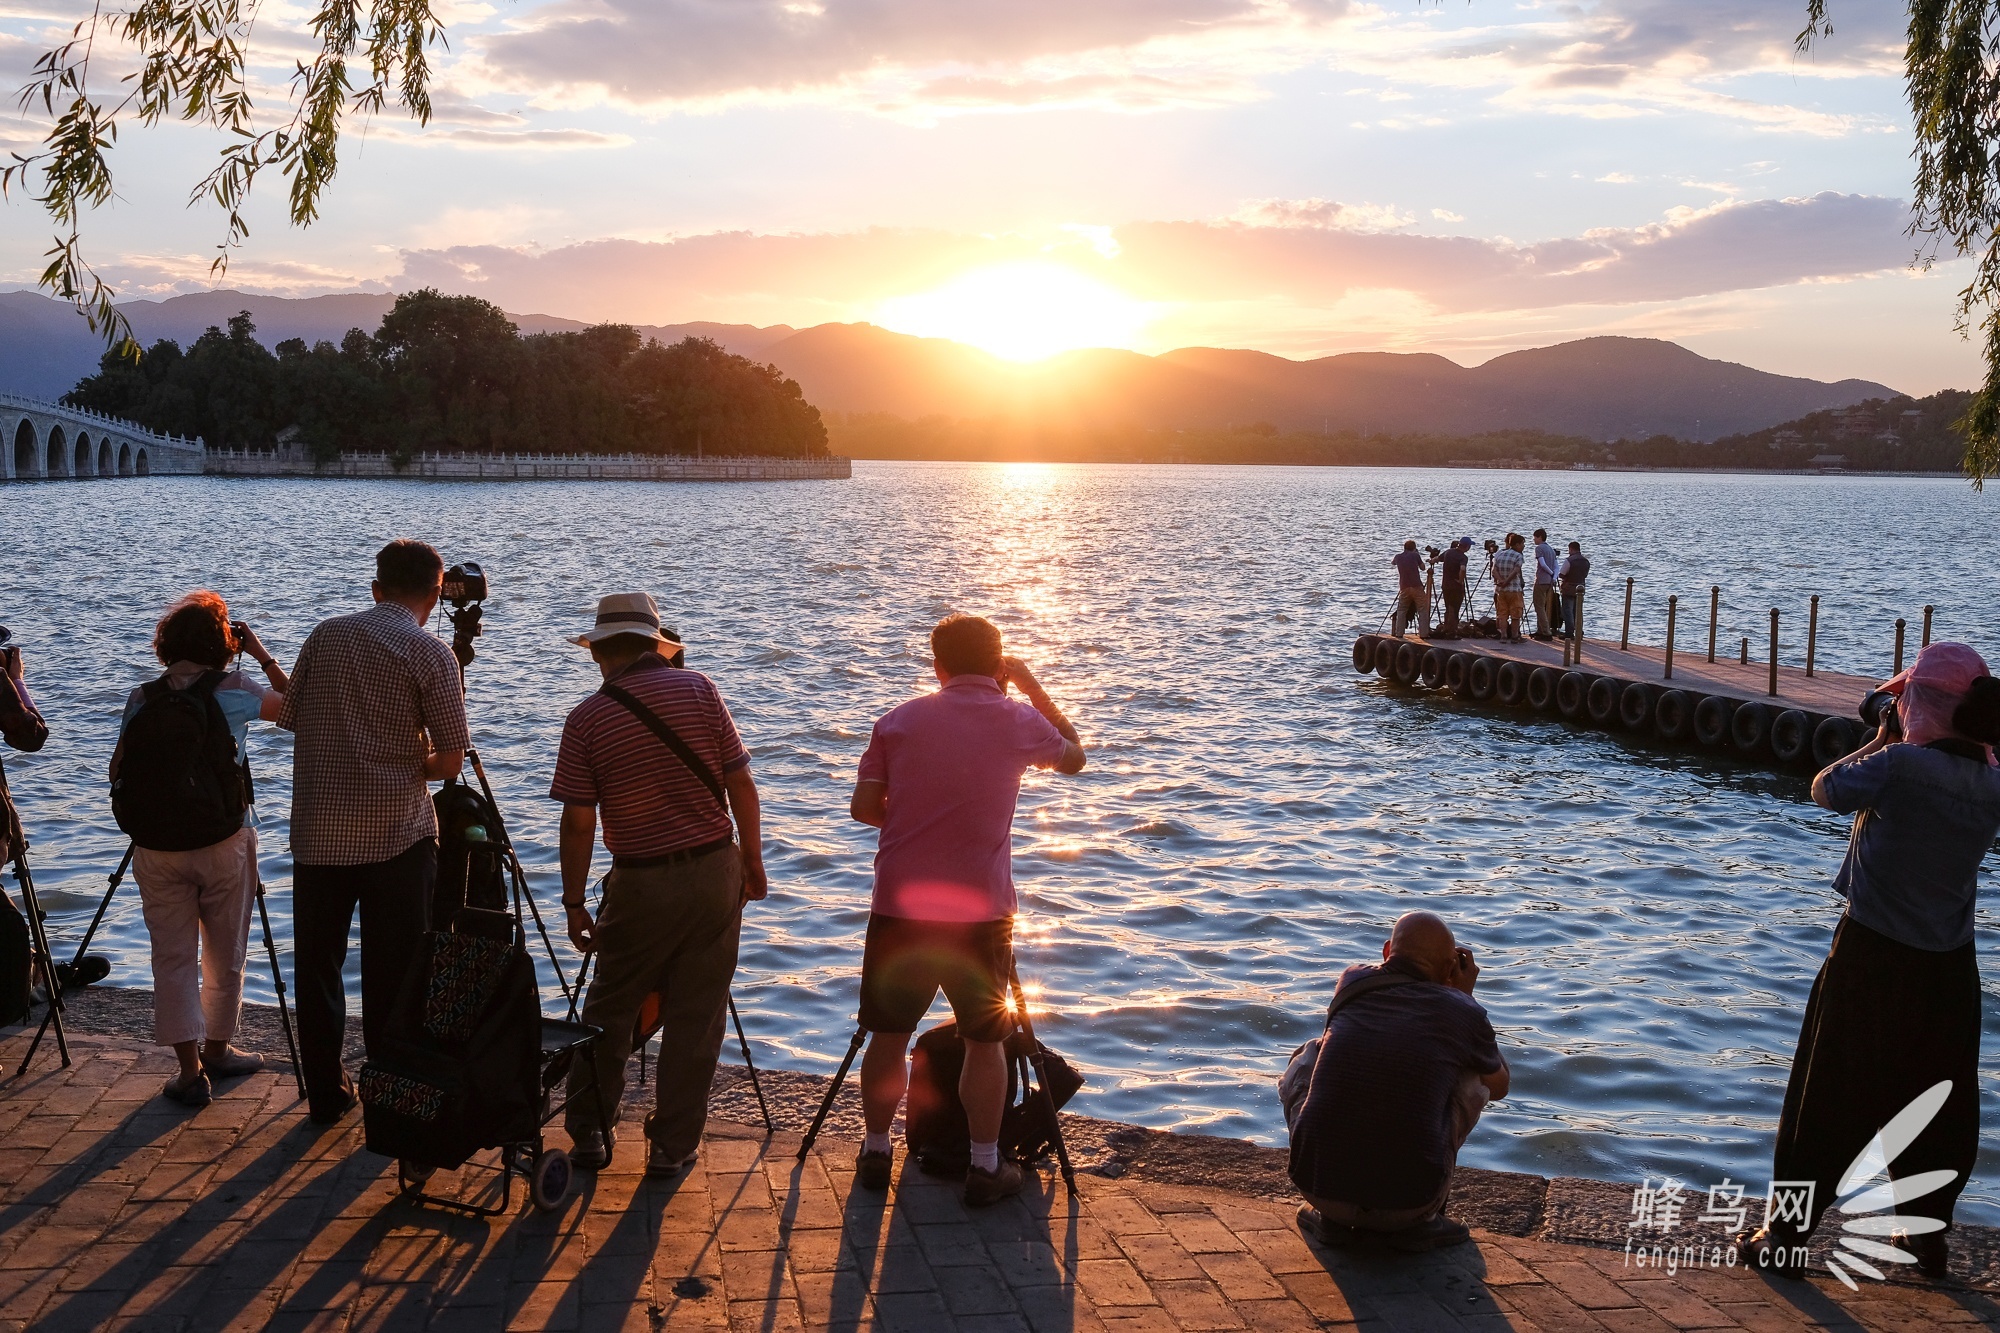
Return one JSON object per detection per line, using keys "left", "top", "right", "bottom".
{"left": 66, "top": 288, "right": 826, "bottom": 460}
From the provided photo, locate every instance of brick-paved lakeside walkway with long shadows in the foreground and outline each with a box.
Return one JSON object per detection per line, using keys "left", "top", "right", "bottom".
{"left": 0, "top": 1037, "right": 2000, "bottom": 1333}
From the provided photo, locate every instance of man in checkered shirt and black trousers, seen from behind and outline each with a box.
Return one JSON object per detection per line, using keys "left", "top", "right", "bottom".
{"left": 278, "top": 540, "right": 470, "bottom": 1125}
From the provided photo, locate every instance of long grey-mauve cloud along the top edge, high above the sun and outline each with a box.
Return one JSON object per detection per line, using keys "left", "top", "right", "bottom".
{"left": 466, "top": 0, "right": 1348, "bottom": 110}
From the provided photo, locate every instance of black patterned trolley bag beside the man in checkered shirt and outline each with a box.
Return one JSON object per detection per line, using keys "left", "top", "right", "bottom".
{"left": 360, "top": 909, "right": 542, "bottom": 1167}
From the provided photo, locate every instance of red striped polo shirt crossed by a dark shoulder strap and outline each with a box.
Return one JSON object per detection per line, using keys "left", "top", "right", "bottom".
{"left": 548, "top": 652, "right": 750, "bottom": 857}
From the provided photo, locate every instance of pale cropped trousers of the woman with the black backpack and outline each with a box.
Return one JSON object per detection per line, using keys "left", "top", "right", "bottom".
{"left": 132, "top": 829, "right": 258, "bottom": 1047}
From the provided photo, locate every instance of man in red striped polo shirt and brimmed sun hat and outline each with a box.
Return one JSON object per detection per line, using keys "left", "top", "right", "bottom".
{"left": 548, "top": 592, "right": 766, "bottom": 1177}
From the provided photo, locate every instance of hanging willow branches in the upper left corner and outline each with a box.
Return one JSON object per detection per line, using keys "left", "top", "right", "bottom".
{"left": 0, "top": 0, "right": 444, "bottom": 348}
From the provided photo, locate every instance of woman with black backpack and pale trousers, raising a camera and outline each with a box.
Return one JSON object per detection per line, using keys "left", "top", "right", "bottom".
{"left": 110, "top": 588, "right": 288, "bottom": 1107}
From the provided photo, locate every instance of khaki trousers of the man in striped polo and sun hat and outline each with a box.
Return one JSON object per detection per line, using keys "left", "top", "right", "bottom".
{"left": 564, "top": 847, "right": 744, "bottom": 1159}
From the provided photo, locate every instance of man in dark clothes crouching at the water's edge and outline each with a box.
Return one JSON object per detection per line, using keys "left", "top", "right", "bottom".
{"left": 1280, "top": 913, "right": 1508, "bottom": 1251}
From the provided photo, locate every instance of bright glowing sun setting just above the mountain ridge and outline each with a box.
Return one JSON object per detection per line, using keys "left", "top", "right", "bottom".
{"left": 874, "top": 260, "right": 1154, "bottom": 360}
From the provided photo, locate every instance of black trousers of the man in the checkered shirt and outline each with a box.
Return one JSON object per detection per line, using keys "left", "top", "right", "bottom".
{"left": 292, "top": 839, "right": 438, "bottom": 1115}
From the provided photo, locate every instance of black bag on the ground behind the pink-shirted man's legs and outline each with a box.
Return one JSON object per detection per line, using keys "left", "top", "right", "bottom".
{"left": 902, "top": 1023, "right": 1084, "bottom": 1179}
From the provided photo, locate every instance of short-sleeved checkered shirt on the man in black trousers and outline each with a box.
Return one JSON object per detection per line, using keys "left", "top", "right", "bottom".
{"left": 278, "top": 602, "right": 472, "bottom": 865}
